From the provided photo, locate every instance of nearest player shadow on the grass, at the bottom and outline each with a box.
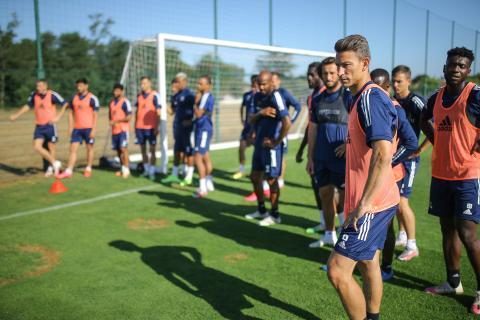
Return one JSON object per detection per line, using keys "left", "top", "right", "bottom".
{"left": 109, "top": 240, "right": 319, "bottom": 319}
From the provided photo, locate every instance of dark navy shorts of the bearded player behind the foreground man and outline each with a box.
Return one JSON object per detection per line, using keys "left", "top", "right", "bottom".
{"left": 313, "top": 158, "right": 345, "bottom": 190}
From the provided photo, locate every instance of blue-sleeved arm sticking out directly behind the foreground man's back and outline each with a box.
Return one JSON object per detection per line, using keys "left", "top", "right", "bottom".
{"left": 392, "top": 107, "right": 418, "bottom": 166}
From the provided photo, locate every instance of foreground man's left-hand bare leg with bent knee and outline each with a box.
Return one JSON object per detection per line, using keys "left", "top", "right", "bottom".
{"left": 328, "top": 251, "right": 367, "bottom": 320}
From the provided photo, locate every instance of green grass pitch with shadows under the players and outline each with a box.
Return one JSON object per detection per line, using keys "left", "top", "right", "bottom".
{"left": 0, "top": 141, "right": 475, "bottom": 320}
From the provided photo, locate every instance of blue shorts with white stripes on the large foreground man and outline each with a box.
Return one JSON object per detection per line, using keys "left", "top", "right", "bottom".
{"left": 335, "top": 205, "right": 398, "bottom": 261}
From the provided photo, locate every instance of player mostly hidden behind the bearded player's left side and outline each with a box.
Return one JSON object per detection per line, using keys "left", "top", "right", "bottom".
{"left": 295, "top": 62, "right": 325, "bottom": 234}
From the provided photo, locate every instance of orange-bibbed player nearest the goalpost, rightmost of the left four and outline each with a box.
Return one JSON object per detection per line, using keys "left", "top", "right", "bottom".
{"left": 135, "top": 76, "right": 162, "bottom": 180}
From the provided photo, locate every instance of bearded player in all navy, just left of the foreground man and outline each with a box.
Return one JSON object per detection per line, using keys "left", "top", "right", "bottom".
{"left": 307, "top": 57, "right": 352, "bottom": 248}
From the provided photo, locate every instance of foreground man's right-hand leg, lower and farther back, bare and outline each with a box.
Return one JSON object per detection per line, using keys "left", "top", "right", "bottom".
{"left": 358, "top": 250, "right": 383, "bottom": 319}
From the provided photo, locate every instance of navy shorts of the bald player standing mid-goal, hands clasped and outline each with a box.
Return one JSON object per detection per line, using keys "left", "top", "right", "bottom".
{"left": 252, "top": 144, "right": 283, "bottom": 178}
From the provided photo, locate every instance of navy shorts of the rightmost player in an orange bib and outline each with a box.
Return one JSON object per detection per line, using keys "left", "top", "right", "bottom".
{"left": 428, "top": 177, "right": 480, "bottom": 223}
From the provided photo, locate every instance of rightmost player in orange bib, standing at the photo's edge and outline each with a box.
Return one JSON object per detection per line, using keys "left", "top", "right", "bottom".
{"left": 421, "top": 47, "right": 480, "bottom": 315}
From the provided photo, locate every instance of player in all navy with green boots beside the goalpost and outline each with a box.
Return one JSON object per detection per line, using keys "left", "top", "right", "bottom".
{"left": 162, "top": 72, "right": 195, "bottom": 185}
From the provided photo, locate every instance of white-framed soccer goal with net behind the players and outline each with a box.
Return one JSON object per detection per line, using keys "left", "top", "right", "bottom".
{"left": 109, "top": 34, "right": 333, "bottom": 170}
